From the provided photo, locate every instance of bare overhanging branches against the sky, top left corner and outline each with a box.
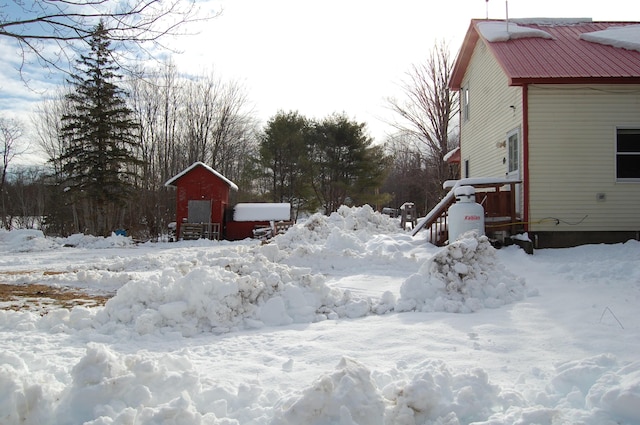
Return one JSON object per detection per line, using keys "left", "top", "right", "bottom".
{"left": 0, "top": 0, "right": 217, "bottom": 73}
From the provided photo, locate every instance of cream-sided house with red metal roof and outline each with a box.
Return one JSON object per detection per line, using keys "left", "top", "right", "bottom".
{"left": 449, "top": 19, "right": 640, "bottom": 247}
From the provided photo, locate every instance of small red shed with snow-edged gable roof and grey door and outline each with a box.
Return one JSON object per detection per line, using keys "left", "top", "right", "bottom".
{"left": 164, "top": 162, "right": 238, "bottom": 240}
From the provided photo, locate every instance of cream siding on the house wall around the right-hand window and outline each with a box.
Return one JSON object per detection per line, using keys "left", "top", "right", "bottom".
{"left": 529, "top": 85, "right": 640, "bottom": 231}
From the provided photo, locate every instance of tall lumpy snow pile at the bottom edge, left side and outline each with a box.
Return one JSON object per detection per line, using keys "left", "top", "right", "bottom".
{"left": 48, "top": 343, "right": 219, "bottom": 425}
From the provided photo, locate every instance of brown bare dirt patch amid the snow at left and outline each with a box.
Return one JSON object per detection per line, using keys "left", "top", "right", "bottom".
{"left": 0, "top": 284, "right": 111, "bottom": 313}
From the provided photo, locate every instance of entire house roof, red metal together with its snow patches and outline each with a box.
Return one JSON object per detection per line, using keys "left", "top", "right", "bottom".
{"left": 449, "top": 18, "right": 640, "bottom": 90}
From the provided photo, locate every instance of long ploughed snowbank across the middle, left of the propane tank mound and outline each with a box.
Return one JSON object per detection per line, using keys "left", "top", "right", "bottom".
{"left": 86, "top": 206, "right": 424, "bottom": 336}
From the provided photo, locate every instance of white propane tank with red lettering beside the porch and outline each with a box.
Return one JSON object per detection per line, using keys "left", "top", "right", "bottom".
{"left": 448, "top": 186, "right": 484, "bottom": 243}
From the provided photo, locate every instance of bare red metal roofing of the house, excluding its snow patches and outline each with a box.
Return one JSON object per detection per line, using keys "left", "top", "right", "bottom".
{"left": 449, "top": 20, "right": 640, "bottom": 90}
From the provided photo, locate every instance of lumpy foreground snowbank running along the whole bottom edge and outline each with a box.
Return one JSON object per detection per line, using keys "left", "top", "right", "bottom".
{"left": 0, "top": 343, "right": 640, "bottom": 425}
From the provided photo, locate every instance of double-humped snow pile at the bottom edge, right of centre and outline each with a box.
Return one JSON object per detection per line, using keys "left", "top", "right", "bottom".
{"left": 272, "top": 358, "right": 505, "bottom": 425}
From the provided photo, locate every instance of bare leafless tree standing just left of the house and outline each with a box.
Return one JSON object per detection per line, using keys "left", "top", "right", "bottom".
{"left": 388, "top": 42, "right": 459, "bottom": 204}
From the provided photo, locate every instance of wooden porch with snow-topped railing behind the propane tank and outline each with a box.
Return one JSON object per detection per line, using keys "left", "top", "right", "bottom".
{"left": 411, "top": 178, "right": 522, "bottom": 246}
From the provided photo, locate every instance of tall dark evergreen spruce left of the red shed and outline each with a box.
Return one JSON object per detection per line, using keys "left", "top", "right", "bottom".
{"left": 58, "top": 23, "right": 140, "bottom": 236}
